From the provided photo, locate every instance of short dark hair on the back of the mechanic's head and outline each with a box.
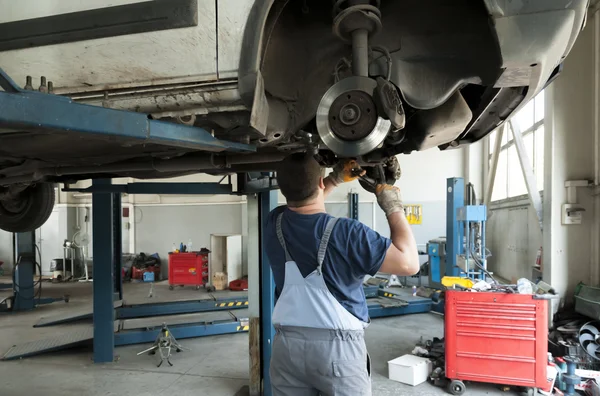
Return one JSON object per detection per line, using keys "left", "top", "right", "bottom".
{"left": 277, "top": 153, "right": 321, "bottom": 204}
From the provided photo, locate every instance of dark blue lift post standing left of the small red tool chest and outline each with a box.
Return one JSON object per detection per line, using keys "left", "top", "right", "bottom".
{"left": 92, "top": 179, "right": 115, "bottom": 363}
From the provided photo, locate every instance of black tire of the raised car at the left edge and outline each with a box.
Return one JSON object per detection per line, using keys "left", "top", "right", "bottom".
{"left": 0, "top": 183, "right": 55, "bottom": 232}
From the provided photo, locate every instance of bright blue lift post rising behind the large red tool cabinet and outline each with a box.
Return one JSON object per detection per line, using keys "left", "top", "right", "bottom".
{"left": 446, "top": 177, "right": 465, "bottom": 276}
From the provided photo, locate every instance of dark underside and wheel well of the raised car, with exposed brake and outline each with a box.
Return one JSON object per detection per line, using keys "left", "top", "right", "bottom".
{"left": 0, "top": 0, "right": 587, "bottom": 231}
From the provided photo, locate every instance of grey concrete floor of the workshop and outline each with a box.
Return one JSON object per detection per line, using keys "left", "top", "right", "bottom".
{"left": 0, "top": 283, "right": 507, "bottom": 396}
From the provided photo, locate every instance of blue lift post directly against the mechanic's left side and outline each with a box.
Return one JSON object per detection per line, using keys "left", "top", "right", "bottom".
{"left": 258, "top": 190, "right": 278, "bottom": 396}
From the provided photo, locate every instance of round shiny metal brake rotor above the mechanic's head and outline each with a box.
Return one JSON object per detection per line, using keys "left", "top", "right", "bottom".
{"left": 316, "top": 77, "right": 391, "bottom": 157}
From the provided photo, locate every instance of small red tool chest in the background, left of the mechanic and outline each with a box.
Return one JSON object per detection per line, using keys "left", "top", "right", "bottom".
{"left": 169, "top": 252, "right": 208, "bottom": 290}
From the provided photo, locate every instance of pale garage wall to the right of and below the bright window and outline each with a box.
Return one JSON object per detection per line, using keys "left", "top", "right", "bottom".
{"left": 487, "top": 17, "right": 600, "bottom": 300}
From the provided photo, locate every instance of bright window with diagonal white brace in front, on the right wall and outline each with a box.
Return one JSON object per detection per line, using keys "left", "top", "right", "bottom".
{"left": 488, "top": 91, "right": 544, "bottom": 201}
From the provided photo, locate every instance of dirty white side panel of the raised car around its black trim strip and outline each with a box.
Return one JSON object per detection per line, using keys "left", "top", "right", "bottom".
{"left": 0, "top": 0, "right": 230, "bottom": 92}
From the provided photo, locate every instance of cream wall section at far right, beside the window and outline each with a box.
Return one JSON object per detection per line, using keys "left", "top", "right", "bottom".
{"left": 544, "top": 17, "right": 600, "bottom": 298}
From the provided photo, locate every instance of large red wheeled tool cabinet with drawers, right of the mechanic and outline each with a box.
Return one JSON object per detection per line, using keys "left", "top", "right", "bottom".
{"left": 445, "top": 290, "right": 548, "bottom": 395}
